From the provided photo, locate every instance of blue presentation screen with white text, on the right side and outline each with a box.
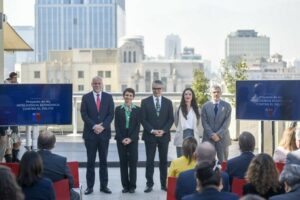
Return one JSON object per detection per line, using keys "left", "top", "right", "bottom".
{"left": 236, "top": 80, "right": 300, "bottom": 121}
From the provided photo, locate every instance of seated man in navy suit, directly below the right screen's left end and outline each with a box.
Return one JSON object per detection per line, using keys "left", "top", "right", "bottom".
{"left": 226, "top": 131, "right": 255, "bottom": 185}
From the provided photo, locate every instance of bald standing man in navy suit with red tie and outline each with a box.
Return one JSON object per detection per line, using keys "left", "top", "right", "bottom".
{"left": 80, "top": 76, "right": 114, "bottom": 195}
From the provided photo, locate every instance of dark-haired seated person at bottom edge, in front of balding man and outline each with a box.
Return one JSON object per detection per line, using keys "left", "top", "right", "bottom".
{"left": 182, "top": 161, "right": 239, "bottom": 200}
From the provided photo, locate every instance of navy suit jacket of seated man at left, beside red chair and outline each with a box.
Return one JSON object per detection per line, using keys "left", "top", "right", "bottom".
{"left": 38, "top": 150, "right": 74, "bottom": 188}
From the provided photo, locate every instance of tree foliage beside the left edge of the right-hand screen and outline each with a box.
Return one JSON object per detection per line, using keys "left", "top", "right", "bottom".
{"left": 222, "top": 60, "right": 248, "bottom": 105}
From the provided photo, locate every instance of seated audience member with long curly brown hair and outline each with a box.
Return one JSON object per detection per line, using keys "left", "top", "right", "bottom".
{"left": 243, "top": 153, "right": 284, "bottom": 199}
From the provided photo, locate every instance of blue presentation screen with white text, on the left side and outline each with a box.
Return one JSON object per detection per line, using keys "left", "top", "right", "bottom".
{"left": 0, "top": 84, "right": 72, "bottom": 126}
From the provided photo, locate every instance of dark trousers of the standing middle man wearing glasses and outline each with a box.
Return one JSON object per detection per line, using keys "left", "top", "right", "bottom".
{"left": 145, "top": 139, "right": 169, "bottom": 187}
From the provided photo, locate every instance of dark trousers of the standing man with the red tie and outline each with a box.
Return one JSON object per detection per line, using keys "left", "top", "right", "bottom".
{"left": 84, "top": 138, "right": 109, "bottom": 188}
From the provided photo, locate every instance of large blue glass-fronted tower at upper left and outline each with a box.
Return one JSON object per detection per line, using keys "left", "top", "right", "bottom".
{"left": 35, "top": 0, "right": 125, "bottom": 61}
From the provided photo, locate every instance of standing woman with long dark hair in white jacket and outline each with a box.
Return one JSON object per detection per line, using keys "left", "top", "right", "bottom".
{"left": 174, "top": 88, "right": 203, "bottom": 157}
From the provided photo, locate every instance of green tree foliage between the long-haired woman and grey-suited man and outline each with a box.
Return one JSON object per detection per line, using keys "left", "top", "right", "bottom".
{"left": 192, "top": 69, "right": 209, "bottom": 106}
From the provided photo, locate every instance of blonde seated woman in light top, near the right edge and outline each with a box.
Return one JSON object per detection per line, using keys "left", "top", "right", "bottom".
{"left": 273, "top": 128, "right": 297, "bottom": 163}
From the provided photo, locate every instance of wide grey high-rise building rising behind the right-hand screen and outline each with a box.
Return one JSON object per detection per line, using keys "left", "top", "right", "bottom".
{"left": 225, "top": 30, "right": 270, "bottom": 63}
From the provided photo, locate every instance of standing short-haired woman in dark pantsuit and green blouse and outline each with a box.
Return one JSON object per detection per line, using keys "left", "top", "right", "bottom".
{"left": 115, "top": 88, "right": 141, "bottom": 193}
